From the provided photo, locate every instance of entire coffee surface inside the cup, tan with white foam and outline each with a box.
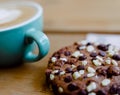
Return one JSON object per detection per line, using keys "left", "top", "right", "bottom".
{"left": 0, "top": 3, "right": 37, "bottom": 29}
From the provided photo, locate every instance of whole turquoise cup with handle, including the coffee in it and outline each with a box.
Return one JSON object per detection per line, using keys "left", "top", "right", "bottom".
{"left": 0, "top": 1, "right": 50, "bottom": 67}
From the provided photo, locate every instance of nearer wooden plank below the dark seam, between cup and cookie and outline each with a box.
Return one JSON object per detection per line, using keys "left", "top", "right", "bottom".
{"left": 0, "top": 33, "right": 85, "bottom": 95}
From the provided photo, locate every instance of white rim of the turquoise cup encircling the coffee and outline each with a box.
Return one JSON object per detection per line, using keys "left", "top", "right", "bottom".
{"left": 0, "top": 1, "right": 43, "bottom": 32}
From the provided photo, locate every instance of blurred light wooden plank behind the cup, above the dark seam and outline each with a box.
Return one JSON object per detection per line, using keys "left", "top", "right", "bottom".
{"left": 0, "top": 0, "right": 120, "bottom": 33}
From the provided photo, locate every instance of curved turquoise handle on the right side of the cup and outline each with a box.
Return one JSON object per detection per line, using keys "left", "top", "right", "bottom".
{"left": 24, "top": 29, "right": 50, "bottom": 62}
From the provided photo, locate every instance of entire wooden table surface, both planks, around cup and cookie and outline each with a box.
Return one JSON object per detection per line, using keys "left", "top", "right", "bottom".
{"left": 0, "top": 0, "right": 120, "bottom": 95}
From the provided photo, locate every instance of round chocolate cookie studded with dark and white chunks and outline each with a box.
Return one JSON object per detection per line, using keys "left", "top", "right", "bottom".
{"left": 46, "top": 41, "right": 120, "bottom": 95}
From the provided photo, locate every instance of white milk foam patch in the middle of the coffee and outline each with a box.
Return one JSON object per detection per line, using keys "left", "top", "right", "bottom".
{"left": 0, "top": 8, "right": 22, "bottom": 24}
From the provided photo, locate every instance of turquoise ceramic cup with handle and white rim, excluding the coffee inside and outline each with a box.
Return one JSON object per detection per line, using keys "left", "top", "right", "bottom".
{"left": 0, "top": 2, "right": 50, "bottom": 67}
